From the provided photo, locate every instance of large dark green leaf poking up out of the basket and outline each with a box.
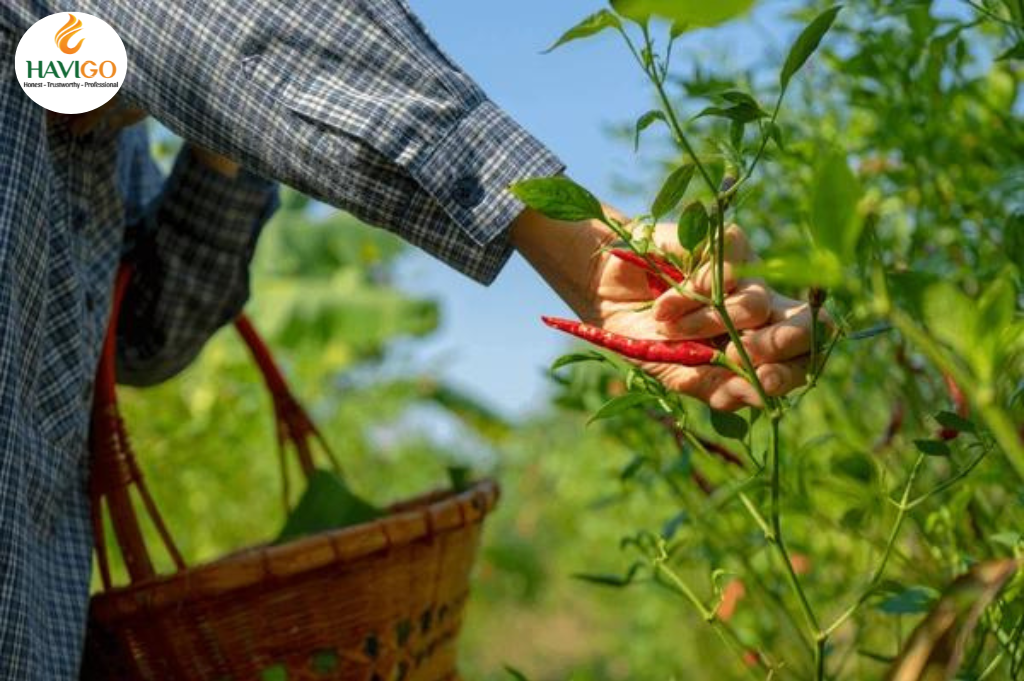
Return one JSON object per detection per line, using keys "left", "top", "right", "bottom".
{"left": 274, "top": 470, "right": 383, "bottom": 544}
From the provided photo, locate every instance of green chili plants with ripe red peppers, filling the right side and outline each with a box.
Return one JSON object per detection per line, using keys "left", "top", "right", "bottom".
{"left": 513, "top": 0, "right": 1024, "bottom": 681}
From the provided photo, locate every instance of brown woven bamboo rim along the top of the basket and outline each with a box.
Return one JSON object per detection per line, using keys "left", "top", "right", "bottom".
{"left": 90, "top": 478, "right": 500, "bottom": 620}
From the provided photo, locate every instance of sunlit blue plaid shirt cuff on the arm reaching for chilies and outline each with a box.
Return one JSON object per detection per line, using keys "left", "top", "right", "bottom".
{"left": 409, "top": 99, "right": 565, "bottom": 254}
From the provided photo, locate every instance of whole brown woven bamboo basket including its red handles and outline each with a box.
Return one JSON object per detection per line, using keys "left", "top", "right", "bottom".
{"left": 82, "top": 269, "right": 498, "bottom": 681}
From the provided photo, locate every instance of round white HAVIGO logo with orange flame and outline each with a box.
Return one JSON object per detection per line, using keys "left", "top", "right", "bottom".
{"left": 14, "top": 12, "right": 128, "bottom": 114}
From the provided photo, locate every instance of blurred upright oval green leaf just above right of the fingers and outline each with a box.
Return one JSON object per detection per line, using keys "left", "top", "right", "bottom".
{"left": 811, "top": 146, "right": 863, "bottom": 264}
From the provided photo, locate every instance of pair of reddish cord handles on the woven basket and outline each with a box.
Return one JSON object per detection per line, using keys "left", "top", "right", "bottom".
{"left": 89, "top": 264, "right": 340, "bottom": 591}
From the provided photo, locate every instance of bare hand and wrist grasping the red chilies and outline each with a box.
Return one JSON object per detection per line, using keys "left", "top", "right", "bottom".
{"left": 512, "top": 206, "right": 823, "bottom": 411}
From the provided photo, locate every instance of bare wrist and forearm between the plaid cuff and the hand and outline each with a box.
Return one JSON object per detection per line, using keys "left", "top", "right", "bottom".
{"left": 511, "top": 208, "right": 615, "bottom": 323}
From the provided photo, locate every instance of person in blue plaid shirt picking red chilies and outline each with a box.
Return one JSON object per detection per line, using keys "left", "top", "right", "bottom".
{"left": 0, "top": 0, "right": 809, "bottom": 681}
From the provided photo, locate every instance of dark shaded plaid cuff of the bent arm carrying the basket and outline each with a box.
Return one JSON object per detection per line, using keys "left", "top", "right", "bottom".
{"left": 158, "top": 150, "right": 279, "bottom": 254}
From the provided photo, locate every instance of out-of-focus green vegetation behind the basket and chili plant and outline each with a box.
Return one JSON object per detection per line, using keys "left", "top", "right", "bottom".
{"left": 97, "top": 0, "right": 1024, "bottom": 681}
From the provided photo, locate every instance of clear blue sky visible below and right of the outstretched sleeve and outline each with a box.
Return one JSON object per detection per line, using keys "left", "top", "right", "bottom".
{"left": 400, "top": 0, "right": 794, "bottom": 415}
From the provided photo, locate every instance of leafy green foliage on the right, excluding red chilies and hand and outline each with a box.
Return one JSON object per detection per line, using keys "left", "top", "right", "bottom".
{"left": 513, "top": 0, "right": 1024, "bottom": 679}
